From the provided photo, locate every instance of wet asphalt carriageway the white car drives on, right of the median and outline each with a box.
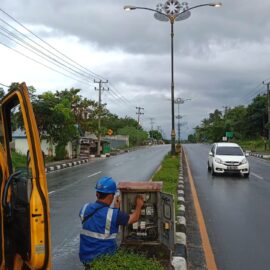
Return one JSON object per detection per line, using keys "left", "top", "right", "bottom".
{"left": 184, "top": 144, "right": 270, "bottom": 270}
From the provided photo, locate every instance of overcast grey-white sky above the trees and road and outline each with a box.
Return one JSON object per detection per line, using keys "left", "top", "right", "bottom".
{"left": 0, "top": 0, "right": 270, "bottom": 138}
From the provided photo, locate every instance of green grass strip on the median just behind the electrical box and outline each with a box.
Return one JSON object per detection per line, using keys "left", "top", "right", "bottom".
{"left": 153, "top": 155, "right": 179, "bottom": 198}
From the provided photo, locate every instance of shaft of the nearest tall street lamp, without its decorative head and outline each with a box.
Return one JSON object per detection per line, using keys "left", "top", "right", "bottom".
{"left": 170, "top": 17, "right": 175, "bottom": 155}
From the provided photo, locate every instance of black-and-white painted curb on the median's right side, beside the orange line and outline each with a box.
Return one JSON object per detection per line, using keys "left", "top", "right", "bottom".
{"left": 171, "top": 151, "right": 187, "bottom": 270}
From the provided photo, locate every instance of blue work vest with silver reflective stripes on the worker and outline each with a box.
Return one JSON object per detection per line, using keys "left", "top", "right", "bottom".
{"left": 79, "top": 201, "right": 129, "bottom": 263}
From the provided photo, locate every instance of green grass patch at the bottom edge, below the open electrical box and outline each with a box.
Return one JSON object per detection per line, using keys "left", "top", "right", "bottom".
{"left": 86, "top": 249, "right": 164, "bottom": 270}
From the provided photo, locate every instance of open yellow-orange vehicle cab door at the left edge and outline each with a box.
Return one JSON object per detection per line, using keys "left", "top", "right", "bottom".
{"left": 0, "top": 83, "right": 51, "bottom": 270}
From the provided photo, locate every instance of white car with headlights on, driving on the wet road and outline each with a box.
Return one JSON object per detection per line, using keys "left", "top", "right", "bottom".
{"left": 207, "top": 143, "right": 250, "bottom": 177}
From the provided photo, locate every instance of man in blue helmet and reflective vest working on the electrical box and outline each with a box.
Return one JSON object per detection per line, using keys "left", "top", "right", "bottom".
{"left": 79, "top": 176, "right": 144, "bottom": 266}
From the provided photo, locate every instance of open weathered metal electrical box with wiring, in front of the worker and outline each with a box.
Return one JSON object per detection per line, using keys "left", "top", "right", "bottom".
{"left": 118, "top": 182, "right": 175, "bottom": 250}
